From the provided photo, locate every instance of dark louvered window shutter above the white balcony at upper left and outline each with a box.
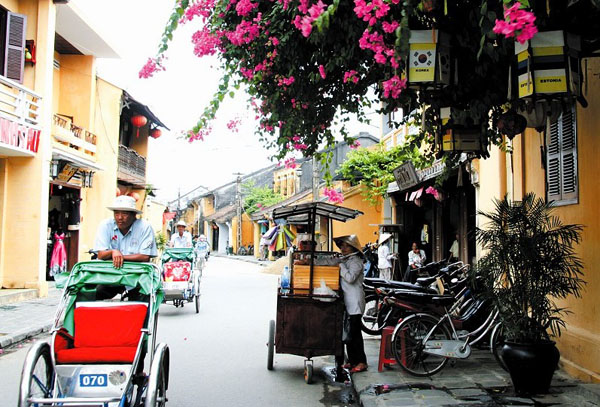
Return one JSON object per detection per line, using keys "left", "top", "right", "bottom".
{"left": 4, "top": 12, "right": 27, "bottom": 83}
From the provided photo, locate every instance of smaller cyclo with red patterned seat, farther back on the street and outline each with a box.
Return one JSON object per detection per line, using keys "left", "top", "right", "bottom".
{"left": 160, "top": 247, "right": 202, "bottom": 313}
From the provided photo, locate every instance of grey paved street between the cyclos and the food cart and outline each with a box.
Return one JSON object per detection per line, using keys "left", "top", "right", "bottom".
{"left": 0, "top": 257, "right": 351, "bottom": 407}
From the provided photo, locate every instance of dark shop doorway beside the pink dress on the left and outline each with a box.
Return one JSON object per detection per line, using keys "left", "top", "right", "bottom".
{"left": 46, "top": 182, "right": 81, "bottom": 281}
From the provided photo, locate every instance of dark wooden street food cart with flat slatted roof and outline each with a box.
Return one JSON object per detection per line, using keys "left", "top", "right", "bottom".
{"left": 267, "top": 202, "right": 362, "bottom": 383}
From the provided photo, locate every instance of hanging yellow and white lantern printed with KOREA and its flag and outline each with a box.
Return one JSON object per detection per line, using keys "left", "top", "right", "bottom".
{"left": 405, "top": 30, "right": 456, "bottom": 89}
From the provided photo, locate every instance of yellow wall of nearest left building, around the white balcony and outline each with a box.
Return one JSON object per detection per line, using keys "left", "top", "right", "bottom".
{"left": 0, "top": 0, "right": 56, "bottom": 295}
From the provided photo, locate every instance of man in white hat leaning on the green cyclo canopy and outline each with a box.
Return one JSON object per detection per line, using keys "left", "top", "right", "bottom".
{"left": 94, "top": 195, "right": 157, "bottom": 268}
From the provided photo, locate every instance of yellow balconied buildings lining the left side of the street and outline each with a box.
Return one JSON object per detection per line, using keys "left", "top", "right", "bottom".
{"left": 0, "top": 0, "right": 164, "bottom": 296}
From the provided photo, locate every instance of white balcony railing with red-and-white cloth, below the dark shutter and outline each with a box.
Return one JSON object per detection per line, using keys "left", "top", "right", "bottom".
{"left": 0, "top": 76, "right": 42, "bottom": 156}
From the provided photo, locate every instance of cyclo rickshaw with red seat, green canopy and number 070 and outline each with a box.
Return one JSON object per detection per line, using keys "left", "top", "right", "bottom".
{"left": 18, "top": 260, "right": 169, "bottom": 407}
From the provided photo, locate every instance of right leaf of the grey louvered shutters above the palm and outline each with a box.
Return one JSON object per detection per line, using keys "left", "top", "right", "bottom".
{"left": 560, "top": 106, "right": 577, "bottom": 200}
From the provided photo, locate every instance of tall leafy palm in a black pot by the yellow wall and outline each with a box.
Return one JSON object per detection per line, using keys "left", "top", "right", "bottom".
{"left": 476, "top": 193, "right": 585, "bottom": 394}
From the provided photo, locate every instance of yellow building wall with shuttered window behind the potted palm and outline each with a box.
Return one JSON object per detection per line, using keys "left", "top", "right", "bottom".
{"left": 473, "top": 58, "right": 600, "bottom": 382}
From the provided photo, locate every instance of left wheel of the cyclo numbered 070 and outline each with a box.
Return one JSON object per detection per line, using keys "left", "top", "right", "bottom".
{"left": 19, "top": 342, "right": 54, "bottom": 407}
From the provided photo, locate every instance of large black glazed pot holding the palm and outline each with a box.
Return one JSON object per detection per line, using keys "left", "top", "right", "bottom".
{"left": 500, "top": 341, "right": 560, "bottom": 395}
